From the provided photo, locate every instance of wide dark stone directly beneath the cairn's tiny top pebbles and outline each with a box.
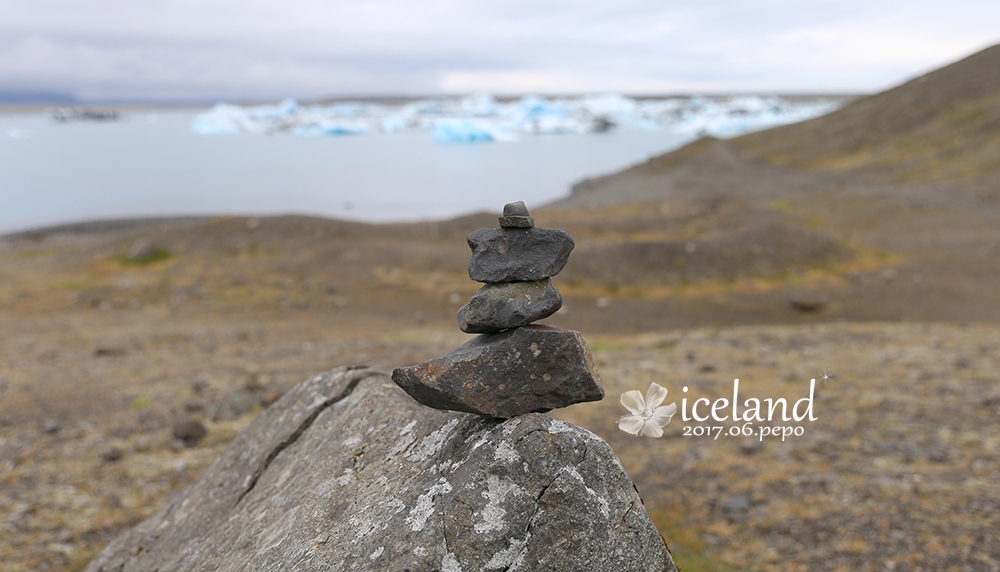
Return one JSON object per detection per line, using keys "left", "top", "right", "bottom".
{"left": 467, "top": 227, "right": 575, "bottom": 283}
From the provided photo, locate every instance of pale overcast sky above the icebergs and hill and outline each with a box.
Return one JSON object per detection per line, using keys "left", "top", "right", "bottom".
{"left": 0, "top": 0, "right": 1000, "bottom": 99}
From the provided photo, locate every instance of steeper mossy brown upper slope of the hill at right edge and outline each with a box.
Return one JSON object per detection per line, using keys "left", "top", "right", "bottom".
{"left": 732, "top": 45, "right": 1000, "bottom": 190}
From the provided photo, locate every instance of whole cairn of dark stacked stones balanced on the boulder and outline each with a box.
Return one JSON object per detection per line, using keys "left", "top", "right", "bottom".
{"left": 392, "top": 201, "right": 604, "bottom": 419}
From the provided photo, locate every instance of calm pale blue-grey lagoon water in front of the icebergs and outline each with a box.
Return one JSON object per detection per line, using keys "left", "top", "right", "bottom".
{"left": 0, "top": 112, "right": 691, "bottom": 233}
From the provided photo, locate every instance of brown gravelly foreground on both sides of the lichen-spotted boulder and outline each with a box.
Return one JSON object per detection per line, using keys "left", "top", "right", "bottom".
{"left": 0, "top": 310, "right": 1000, "bottom": 571}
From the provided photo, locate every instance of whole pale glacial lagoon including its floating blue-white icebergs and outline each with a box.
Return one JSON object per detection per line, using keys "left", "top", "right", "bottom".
{"left": 0, "top": 97, "right": 836, "bottom": 233}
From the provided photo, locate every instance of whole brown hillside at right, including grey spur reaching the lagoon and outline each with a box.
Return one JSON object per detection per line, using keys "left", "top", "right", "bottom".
{"left": 555, "top": 45, "right": 1000, "bottom": 207}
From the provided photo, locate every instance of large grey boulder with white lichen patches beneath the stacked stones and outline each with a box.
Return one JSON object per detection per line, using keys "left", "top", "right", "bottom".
{"left": 86, "top": 368, "right": 676, "bottom": 572}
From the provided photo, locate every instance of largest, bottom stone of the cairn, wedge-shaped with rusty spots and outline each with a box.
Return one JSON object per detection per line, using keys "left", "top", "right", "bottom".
{"left": 392, "top": 325, "right": 604, "bottom": 418}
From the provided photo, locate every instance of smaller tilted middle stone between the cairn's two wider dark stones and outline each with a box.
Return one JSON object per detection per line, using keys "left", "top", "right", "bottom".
{"left": 458, "top": 278, "right": 562, "bottom": 334}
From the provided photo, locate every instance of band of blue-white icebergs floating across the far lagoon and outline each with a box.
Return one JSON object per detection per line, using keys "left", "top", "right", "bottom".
{"left": 192, "top": 93, "right": 840, "bottom": 144}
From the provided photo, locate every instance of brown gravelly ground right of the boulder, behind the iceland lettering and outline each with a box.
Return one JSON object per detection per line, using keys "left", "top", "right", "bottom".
{"left": 555, "top": 324, "right": 1000, "bottom": 571}
